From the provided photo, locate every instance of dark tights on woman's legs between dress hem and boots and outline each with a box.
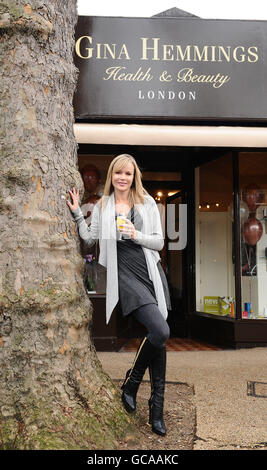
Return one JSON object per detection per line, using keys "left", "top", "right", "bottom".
{"left": 132, "top": 304, "right": 170, "bottom": 348}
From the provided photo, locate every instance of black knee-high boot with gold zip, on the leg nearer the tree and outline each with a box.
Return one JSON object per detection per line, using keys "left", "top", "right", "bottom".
{"left": 121, "top": 337, "right": 159, "bottom": 413}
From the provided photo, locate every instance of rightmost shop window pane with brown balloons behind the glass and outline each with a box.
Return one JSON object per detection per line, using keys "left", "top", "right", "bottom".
{"left": 239, "top": 152, "right": 267, "bottom": 320}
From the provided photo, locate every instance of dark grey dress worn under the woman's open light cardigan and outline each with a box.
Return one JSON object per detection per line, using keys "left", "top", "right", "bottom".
{"left": 116, "top": 208, "right": 171, "bottom": 316}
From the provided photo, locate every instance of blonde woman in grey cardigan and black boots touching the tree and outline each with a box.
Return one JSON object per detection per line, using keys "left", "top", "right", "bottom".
{"left": 67, "top": 154, "right": 170, "bottom": 436}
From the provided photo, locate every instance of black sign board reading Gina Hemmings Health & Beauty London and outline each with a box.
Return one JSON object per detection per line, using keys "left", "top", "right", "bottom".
{"left": 74, "top": 16, "right": 267, "bottom": 121}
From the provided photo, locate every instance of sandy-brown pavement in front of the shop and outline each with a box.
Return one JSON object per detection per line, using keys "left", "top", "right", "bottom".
{"left": 97, "top": 347, "right": 267, "bottom": 450}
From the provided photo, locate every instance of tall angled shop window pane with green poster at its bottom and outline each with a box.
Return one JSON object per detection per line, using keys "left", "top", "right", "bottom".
{"left": 195, "top": 154, "right": 236, "bottom": 317}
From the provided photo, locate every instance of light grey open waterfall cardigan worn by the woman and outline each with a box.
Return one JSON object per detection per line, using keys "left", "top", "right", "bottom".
{"left": 73, "top": 193, "right": 168, "bottom": 323}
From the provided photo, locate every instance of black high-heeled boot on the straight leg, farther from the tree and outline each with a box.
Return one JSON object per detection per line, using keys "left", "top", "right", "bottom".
{"left": 148, "top": 346, "right": 166, "bottom": 436}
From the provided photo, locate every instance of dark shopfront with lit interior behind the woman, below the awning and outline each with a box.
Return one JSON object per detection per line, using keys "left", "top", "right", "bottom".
{"left": 78, "top": 144, "right": 267, "bottom": 350}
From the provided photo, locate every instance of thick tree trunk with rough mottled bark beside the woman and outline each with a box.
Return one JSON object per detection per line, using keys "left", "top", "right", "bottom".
{"left": 0, "top": 0, "right": 133, "bottom": 449}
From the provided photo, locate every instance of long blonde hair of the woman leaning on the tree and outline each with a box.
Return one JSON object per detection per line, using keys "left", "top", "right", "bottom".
{"left": 100, "top": 153, "right": 148, "bottom": 207}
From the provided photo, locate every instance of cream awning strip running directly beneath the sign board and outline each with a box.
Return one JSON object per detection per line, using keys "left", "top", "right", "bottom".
{"left": 74, "top": 123, "right": 267, "bottom": 148}
